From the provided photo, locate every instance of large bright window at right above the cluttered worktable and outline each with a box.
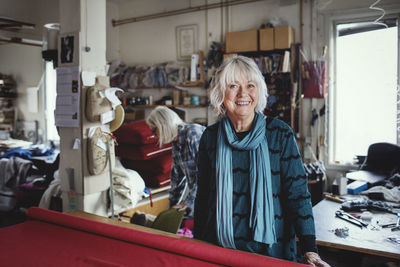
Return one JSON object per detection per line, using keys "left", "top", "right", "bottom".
{"left": 328, "top": 11, "right": 400, "bottom": 164}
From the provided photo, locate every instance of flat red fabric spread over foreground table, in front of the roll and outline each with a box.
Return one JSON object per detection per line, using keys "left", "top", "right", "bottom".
{"left": 0, "top": 220, "right": 219, "bottom": 267}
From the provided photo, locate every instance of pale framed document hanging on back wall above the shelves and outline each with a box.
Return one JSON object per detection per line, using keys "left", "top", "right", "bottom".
{"left": 175, "top": 24, "right": 198, "bottom": 60}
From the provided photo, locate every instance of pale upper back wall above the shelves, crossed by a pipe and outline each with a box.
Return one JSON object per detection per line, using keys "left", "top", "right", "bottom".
{"left": 109, "top": 0, "right": 299, "bottom": 64}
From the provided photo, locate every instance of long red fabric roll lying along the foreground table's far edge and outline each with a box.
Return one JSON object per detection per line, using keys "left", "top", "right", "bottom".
{"left": 21, "top": 207, "right": 304, "bottom": 267}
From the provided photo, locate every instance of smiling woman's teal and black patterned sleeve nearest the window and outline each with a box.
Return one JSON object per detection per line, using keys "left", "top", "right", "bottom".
{"left": 280, "top": 127, "right": 317, "bottom": 253}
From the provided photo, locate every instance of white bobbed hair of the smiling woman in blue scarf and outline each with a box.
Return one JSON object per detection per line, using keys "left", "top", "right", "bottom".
{"left": 210, "top": 56, "right": 268, "bottom": 118}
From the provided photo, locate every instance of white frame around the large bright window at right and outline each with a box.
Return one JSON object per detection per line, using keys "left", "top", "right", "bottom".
{"left": 320, "top": 4, "right": 400, "bottom": 171}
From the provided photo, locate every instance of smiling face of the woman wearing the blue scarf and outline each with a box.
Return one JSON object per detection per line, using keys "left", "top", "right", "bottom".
{"left": 224, "top": 77, "right": 259, "bottom": 120}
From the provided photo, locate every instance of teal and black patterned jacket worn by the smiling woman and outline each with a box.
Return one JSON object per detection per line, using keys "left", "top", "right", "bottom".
{"left": 194, "top": 118, "right": 317, "bottom": 261}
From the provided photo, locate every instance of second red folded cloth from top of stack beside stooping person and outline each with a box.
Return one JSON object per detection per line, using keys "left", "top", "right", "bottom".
{"left": 116, "top": 143, "right": 172, "bottom": 160}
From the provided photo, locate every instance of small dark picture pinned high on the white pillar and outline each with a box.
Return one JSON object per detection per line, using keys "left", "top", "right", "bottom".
{"left": 58, "top": 32, "right": 79, "bottom": 67}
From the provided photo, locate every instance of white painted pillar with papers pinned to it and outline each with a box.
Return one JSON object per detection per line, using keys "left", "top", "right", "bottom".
{"left": 59, "top": 0, "right": 110, "bottom": 215}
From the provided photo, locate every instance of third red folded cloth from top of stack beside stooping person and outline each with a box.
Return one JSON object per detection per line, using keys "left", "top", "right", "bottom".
{"left": 121, "top": 153, "right": 172, "bottom": 173}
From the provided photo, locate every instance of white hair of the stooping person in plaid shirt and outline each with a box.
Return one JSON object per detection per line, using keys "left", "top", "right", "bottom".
{"left": 146, "top": 106, "right": 184, "bottom": 147}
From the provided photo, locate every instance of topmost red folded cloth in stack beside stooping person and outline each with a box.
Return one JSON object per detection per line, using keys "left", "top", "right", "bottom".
{"left": 113, "top": 120, "right": 158, "bottom": 145}
